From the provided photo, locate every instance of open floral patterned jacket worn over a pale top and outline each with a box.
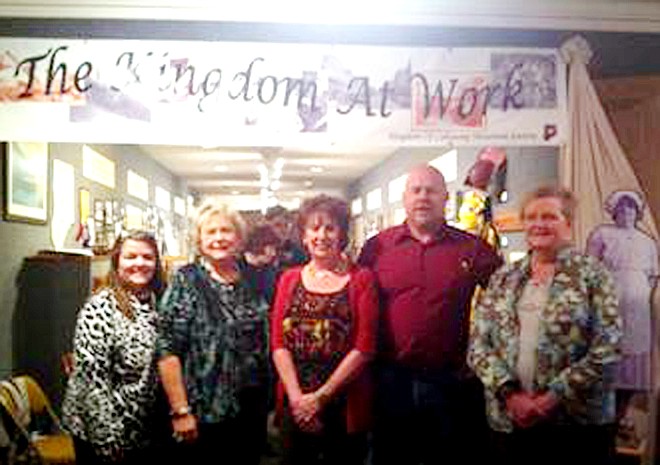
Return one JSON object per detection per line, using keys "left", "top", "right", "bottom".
{"left": 468, "top": 248, "right": 621, "bottom": 432}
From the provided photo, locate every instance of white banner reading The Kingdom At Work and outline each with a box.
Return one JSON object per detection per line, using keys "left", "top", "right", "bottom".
{"left": 0, "top": 38, "right": 567, "bottom": 146}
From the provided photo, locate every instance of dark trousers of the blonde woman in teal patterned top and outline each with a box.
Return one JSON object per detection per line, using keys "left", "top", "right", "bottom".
{"left": 160, "top": 388, "right": 268, "bottom": 465}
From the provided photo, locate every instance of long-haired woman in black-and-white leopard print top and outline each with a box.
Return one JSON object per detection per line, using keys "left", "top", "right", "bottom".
{"left": 63, "top": 232, "right": 163, "bottom": 465}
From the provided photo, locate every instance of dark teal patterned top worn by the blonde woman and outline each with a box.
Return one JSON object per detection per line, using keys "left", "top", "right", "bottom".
{"left": 156, "top": 263, "right": 268, "bottom": 424}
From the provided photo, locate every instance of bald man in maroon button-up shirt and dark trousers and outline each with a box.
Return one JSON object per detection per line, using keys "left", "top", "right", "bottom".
{"left": 359, "top": 165, "right": 501, "bottom": 465}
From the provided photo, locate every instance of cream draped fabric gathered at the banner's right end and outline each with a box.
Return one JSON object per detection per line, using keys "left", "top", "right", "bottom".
{"left": 559, "top": 36, "right": 658, "bottom": 248}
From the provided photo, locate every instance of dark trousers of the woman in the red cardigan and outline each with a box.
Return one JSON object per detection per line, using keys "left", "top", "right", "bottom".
{"left": 283, "top": 401, "right": 368, "bottom": 465}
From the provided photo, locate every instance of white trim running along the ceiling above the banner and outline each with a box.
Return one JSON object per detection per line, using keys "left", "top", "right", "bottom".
{"left": 0, "top": 0, "right": 660, "bottom": 32}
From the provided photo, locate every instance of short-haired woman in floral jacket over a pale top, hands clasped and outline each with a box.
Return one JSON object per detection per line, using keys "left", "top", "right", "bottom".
{"left": 468, "top": 188, "right": 621, "bottom": 464}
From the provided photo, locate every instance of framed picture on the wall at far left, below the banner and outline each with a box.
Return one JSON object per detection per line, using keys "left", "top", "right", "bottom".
{"left": 3, "top": 142, "right": 48, "bottom": 224}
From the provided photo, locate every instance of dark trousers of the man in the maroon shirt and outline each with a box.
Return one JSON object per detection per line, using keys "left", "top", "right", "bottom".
{"left": 373, "top": 363, "right": 489, "bottom": 465}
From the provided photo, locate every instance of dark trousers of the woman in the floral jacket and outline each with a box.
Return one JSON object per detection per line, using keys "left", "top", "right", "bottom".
{"left": 493, "top": 424, "right": 615, "bottom": 465}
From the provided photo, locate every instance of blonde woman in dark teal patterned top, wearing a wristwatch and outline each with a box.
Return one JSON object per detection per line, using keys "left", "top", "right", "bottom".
{"left": 157, "top": 203, "right": 268, "bottom": 464}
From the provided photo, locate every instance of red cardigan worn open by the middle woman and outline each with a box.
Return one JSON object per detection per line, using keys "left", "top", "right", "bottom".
{"left": 271, "top": 267, "right": 378, "bottom": 432}
